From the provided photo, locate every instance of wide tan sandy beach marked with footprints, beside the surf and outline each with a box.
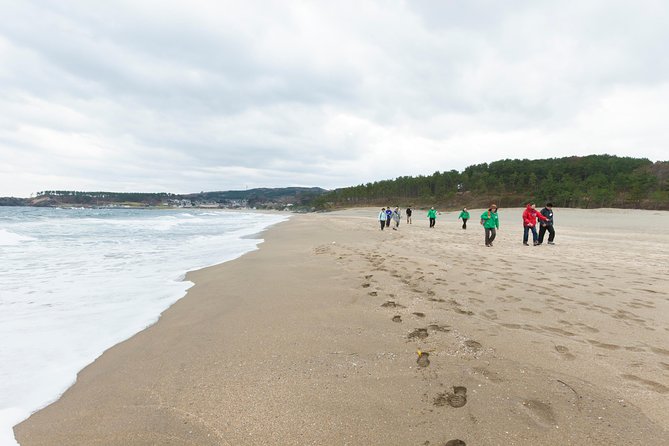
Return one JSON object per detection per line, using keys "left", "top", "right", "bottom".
{"left": 15, "top": 209, "right": 669, "bottom": 446}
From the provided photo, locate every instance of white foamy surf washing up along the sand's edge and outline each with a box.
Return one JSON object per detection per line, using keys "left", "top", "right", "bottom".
{"left": 0, "top": 213, "right": 289, "bottom": 445}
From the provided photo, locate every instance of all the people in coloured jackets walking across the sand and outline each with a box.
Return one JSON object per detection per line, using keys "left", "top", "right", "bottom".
{"left": 379, "top": 203, "right": 555, "bottom": 247}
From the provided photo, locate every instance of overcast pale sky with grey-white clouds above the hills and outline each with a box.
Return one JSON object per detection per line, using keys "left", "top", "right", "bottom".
{"left": 0, "top": 0, "right": 669, "bottom": 197}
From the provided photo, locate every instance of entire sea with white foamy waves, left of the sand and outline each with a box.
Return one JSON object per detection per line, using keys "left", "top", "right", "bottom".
{"left": 0, "top": 207, "right": 288, "bottom": 446}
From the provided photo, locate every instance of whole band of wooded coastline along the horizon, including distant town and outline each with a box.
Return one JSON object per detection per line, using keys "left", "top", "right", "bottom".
{"left": 0, "top": 155, "right": 669, "bottom": 211}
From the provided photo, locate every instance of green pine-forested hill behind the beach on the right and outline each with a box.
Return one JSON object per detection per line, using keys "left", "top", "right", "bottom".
{"left": 316, "top": 155, "right": 669, "bottom": 209}
